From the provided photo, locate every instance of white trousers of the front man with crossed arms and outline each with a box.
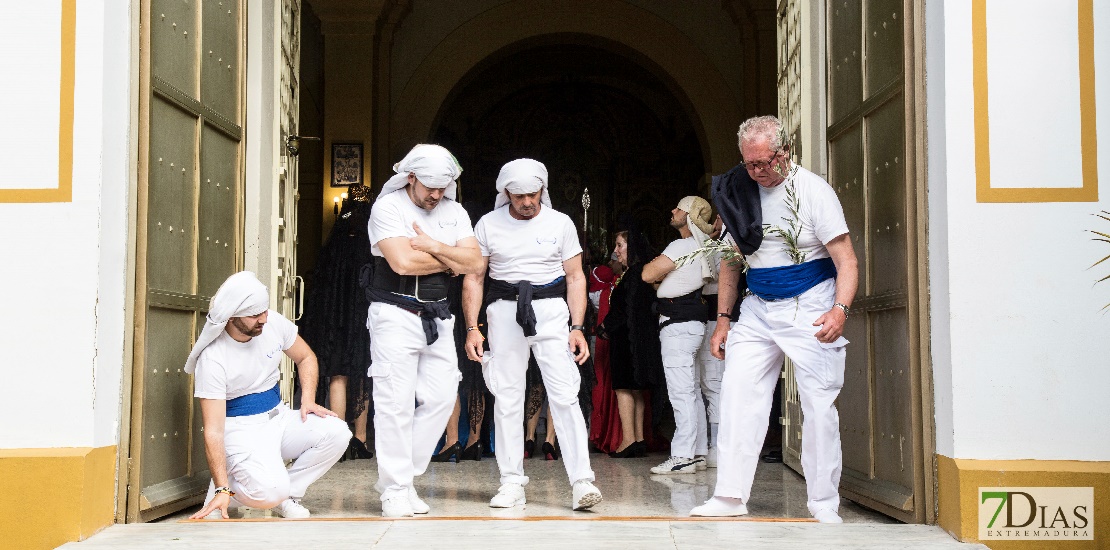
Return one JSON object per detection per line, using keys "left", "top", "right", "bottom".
{"left": 366, "top": 302, "right": 462, "bottom": 500}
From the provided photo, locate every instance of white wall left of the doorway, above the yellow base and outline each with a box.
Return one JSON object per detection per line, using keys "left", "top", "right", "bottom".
{"left": 0, "top": 2, "right": 132, "bottom": 449}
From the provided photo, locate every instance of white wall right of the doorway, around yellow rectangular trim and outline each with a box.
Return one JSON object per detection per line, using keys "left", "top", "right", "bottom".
{"left": 927, "top": 0, "right": 1110, "bottom": 460}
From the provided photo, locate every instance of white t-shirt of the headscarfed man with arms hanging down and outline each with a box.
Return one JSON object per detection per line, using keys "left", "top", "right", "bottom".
{"left": 474, "top": 204, "right": 582, "bottom": 284}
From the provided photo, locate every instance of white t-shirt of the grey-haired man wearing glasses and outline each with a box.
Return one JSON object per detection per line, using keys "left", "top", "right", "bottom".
{"left": 747, "top": 167, "right": 848, "bottom": 268}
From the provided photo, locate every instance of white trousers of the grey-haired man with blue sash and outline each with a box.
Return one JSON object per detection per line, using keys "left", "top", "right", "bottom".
{"left": 715, "top": 279, "right": 848, "bottom": 512}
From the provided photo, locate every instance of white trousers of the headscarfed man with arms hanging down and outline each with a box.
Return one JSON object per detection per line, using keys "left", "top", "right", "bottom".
{"left": 482, "top": 298, "right": 594, "bottom": 486}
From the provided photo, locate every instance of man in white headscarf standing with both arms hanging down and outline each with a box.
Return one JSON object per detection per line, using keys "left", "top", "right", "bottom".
{"left": 463, "top": 159, "right": 602, "bottom": 510}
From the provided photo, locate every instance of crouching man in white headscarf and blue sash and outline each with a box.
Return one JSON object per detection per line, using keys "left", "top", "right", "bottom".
{"left": 185, "top": 271, "right": 351, "bottom": 519}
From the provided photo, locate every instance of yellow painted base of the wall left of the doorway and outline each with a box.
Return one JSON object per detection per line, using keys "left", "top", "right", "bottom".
{"left": 0, "top": 446, "right": 117, "bottom": 549}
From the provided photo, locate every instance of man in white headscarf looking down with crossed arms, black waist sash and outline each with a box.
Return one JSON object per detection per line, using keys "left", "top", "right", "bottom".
{"left": 363, "top": 144, "right": 482, "bottom": 518}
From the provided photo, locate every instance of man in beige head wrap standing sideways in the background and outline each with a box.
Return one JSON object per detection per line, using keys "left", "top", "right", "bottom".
{"left": 642, "top": 197, "right": 713, "bottom": 474}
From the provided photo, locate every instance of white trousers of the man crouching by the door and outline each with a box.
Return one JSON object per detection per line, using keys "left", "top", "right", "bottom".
{"left": 204, "top": 403, "right": 351, "bottom": 509}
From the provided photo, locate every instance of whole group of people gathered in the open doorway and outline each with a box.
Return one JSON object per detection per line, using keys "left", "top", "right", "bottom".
{"left": 185, "top": 117, "right": 858, "bottom": 522}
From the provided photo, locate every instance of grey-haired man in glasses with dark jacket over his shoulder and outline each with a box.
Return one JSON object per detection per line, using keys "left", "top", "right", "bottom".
{"left": 690, "top": 117, "right": 858, "bottom": 523}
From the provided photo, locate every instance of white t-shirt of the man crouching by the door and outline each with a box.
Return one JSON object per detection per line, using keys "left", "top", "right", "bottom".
{"left": 193, "top": 310, "right": 296, "bottom": 399}
